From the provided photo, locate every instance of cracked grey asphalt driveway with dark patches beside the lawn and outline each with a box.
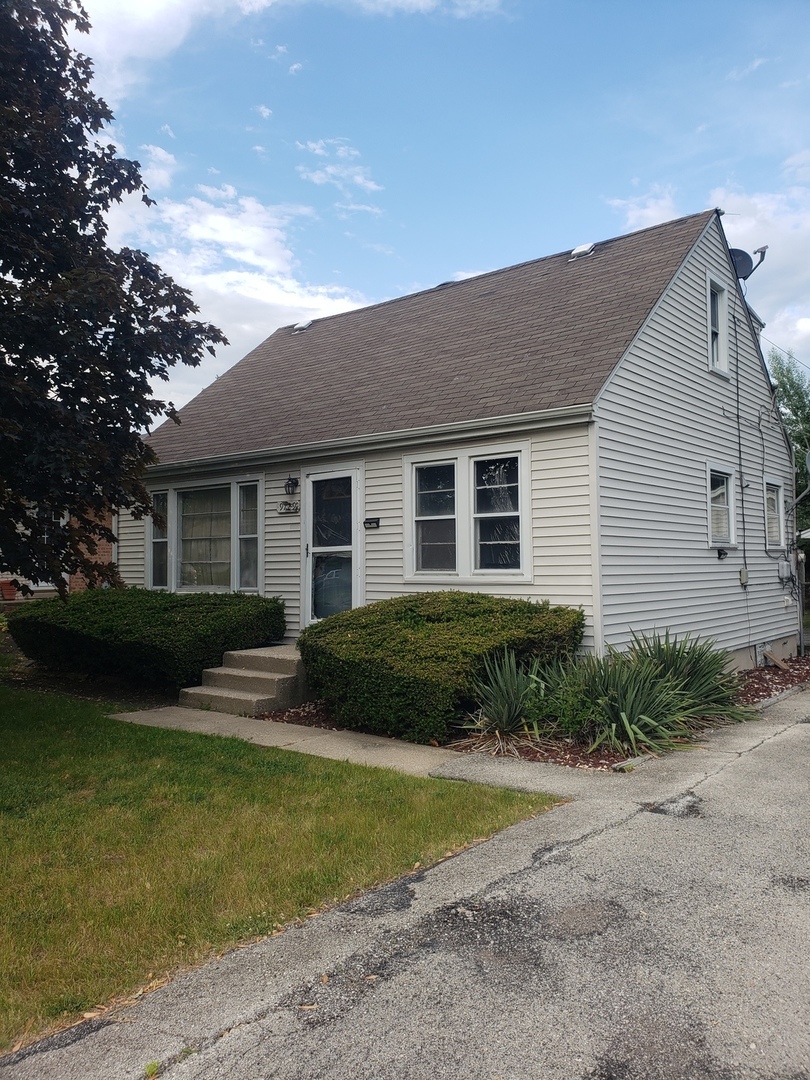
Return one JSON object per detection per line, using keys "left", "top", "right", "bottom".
{"left": 0, "top": 690, "right": 810, "bottom": 1080}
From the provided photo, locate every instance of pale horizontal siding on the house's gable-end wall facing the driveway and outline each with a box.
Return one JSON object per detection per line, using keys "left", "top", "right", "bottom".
{"left": 596, "top": 217, "right": 797, "bottom": 659}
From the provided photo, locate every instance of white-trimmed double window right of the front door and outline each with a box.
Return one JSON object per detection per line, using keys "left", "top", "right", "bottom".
{"left": 405, "top": 445, "right": 529, "bottom": 580}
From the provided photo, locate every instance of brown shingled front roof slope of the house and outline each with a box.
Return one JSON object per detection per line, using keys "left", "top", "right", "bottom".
{"left": 149, "top": 211, "right": 717, "bottom": 464}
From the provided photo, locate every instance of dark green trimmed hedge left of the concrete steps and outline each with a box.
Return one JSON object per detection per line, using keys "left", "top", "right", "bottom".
{"left": 9, "top": 589, "right": 285, "bottom": 687}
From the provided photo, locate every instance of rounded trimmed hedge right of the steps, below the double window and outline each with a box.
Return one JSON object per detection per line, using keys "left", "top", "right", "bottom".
{"left": 298, "top": 592, "right": 584, "bottom": 742}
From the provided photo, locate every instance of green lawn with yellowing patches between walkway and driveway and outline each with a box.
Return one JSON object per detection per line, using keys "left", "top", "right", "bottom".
{"left": 0, "top": 685, "right": 551, "bottom": 1049}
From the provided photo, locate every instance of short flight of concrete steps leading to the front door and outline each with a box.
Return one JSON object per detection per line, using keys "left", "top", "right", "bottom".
{"left": 179, "top": 645, "right": 307, "bottom": 716}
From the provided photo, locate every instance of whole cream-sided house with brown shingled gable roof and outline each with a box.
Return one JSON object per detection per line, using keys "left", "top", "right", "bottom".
{"left": 119, "top": 211, "right": 798, "bottom": 666}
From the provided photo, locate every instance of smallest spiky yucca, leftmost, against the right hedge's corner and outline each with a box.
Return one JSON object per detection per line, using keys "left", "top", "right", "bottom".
{"left": 459, "top": 649, "right": 543, "bottom": 754}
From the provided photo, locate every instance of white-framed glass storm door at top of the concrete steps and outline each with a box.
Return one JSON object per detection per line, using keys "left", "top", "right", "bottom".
{"left": 305, "top": 470, "right": 359, "bottom": 622}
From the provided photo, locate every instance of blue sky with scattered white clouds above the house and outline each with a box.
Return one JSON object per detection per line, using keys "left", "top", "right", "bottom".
{"left": 79, "top": 0, "right": 810, "bottom": 404}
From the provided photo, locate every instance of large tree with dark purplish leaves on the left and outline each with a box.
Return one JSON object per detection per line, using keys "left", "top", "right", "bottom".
{"left": 0, "top": 0, "right": 227, "bottom": 591}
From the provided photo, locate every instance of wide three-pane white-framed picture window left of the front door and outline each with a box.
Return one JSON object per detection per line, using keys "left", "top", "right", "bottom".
{"left": 149, "top": 481, "right": 259, "bottom": 592}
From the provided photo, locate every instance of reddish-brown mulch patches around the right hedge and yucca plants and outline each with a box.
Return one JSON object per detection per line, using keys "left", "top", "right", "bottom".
{"left": 260, "top": 657, "right": 810, "bottom": 772}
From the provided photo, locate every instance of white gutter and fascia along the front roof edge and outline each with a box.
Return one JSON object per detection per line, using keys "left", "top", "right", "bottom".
{"left": 146, "top": 402, "right": 593, "bottom": 484}
